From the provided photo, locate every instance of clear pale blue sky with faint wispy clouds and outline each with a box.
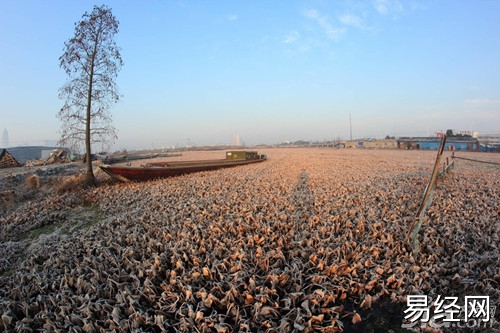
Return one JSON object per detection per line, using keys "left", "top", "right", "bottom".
{"left": 0, "top": 0, "right": 500, "bottom": 150}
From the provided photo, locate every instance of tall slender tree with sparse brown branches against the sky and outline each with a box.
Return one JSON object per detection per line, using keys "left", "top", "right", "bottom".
{"left": 57, "top": 5, "right": 123, "bottom": 185}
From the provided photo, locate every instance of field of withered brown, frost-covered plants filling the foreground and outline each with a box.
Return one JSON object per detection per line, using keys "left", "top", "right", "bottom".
{"left": 0, "top": 149, "right": 500, "bottom": 332}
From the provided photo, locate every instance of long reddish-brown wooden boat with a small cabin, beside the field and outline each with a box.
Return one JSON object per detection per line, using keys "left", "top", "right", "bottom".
{"left": 99, "top": 151, "right": 267, "bottom": 182}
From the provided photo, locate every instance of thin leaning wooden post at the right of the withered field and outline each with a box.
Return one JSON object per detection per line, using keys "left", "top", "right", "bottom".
{"left": 406, "top": 135, "right": 446, "bottom": 257}
